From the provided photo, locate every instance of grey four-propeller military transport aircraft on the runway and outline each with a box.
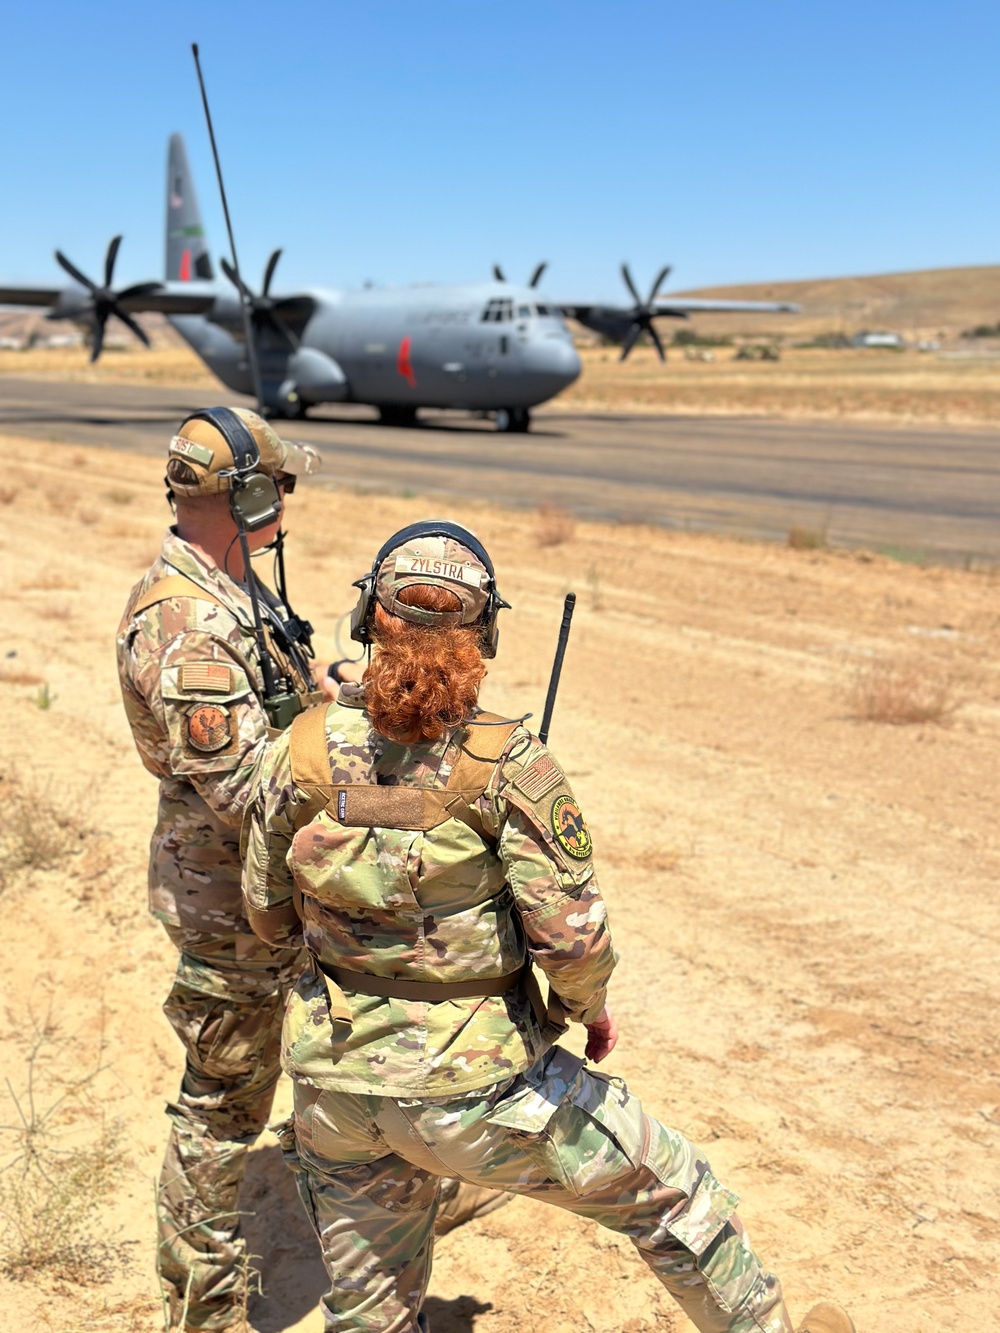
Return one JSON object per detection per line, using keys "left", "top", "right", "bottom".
{"left": 0, "top": 135, "right": 796, "bottom": 431}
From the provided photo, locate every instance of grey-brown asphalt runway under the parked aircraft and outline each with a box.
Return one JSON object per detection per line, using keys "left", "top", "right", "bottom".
{"left": 0, "top": 376, "right": 1000, "bottom": 564}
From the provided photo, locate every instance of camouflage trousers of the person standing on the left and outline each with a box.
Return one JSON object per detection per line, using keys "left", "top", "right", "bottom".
{"left": 157, "top": 926, "right": 303, "bottom": 1329}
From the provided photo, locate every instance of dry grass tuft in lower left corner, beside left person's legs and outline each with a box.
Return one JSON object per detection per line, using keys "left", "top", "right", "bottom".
{"left": 0, "top": 1017, "right": 125, "bottom": 1286}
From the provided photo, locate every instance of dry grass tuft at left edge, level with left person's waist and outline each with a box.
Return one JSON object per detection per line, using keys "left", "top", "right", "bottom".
{"left": 0, "top": 773, "right": 93, "bottom": 893}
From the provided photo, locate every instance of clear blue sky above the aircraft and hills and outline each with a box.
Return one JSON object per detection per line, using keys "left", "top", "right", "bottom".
{"left": 0, "top": 0, "right": 1000, "bottom": 300}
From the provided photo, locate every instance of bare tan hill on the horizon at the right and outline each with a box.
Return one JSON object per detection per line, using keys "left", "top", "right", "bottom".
{"left": 677, "top": 264, "right": 1000, "bottom": 339}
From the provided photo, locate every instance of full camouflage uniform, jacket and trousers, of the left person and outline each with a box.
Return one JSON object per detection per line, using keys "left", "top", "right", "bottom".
{"left": 117, "top": 533, "right": 317, "bottom": 1329}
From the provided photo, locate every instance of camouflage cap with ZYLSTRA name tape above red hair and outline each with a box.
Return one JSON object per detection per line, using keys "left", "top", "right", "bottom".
{"left": 375, "top": 524, "right": 493, "bottom": 628}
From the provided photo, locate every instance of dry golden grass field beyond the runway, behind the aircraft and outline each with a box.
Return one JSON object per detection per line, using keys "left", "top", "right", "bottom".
{"left": 0, "top": 338, "right": 1000, "bottom": 425}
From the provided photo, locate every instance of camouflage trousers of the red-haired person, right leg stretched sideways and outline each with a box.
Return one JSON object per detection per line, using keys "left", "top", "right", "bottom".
{"left": 283, "top": 1046, "right": 792, "bottom": 1333}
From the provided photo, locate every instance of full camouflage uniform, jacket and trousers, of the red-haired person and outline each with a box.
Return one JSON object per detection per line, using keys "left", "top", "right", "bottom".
{"left": 244, "top": 690, "right": 791, "bottom": 1333}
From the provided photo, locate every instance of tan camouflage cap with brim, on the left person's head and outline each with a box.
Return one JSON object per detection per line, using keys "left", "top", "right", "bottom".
{"left": 167, "top": 408, "right": 320, "bottom": 496}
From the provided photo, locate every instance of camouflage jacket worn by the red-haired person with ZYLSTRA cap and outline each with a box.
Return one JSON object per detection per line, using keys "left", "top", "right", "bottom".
{"left": 243, "top": 690, "right": 615, "bottom": 1097}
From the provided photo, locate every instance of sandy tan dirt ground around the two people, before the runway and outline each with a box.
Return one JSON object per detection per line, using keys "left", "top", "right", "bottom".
{"left": 0, "top": 439, "right": 1000, "bottom": 1333}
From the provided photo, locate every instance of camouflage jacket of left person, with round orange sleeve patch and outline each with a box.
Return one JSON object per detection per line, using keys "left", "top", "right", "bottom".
{"left": 117, "top": 531, "right": 311, "bottom": 934}
